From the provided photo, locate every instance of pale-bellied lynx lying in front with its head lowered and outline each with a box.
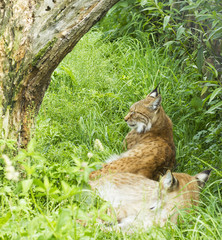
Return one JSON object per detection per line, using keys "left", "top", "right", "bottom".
{"left": 90, "top": 170, "right": 210, "bottom": 231}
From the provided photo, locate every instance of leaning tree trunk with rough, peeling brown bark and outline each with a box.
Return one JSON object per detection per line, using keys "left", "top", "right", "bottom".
{"left": 0, "top": 0, "right": 119, "bottom": 147}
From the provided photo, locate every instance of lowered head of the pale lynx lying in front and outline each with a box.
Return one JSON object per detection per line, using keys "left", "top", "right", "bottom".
{"left": 156, "top": 170, "right": 211, "bottom": 223}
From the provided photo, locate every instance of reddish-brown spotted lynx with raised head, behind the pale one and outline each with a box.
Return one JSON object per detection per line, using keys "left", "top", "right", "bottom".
{"left": 90, "top": 88, "right": 175, "bottom": 180}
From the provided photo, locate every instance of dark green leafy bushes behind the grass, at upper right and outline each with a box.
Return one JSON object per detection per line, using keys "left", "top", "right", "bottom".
{"left": 101, "top": 0, "right": 222, "bottom": 114}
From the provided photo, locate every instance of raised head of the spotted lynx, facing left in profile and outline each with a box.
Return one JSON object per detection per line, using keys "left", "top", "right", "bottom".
{"left": 124, "top": 87, "right": 161, "bottom": 133}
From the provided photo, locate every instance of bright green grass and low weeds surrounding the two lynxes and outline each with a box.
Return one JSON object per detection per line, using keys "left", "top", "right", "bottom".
{"left": 0, "top": 29, "right": 222, "bottom": 240}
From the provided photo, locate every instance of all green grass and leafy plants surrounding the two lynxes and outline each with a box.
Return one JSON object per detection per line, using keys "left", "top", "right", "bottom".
{"left": 0, "top": 1, "right": 222, "bottom": 240}
